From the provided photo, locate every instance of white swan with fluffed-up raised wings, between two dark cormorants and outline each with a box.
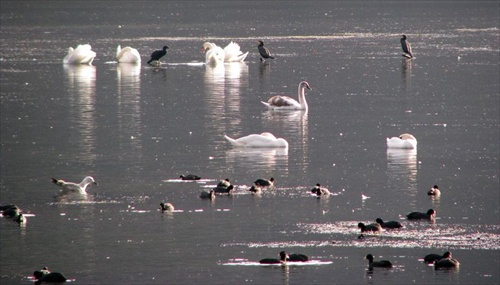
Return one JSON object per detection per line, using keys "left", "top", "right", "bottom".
{"left": 202, "top": 42, "right": 248, "bottom": 65}
